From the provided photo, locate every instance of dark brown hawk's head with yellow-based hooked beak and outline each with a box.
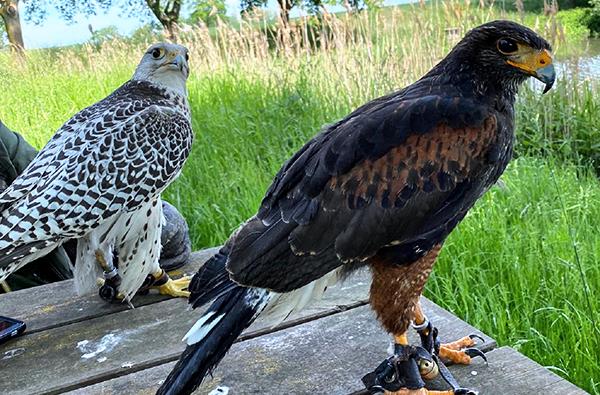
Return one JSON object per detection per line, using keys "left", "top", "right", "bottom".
{"left": 438, "top": 20, "right": 556, "bottom": 93}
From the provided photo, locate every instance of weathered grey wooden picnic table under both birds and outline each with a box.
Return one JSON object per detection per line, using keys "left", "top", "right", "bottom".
{"left": 0, "top": 249, "right": 586, "bottom": 395}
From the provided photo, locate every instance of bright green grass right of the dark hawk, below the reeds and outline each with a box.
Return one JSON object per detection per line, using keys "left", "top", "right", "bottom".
{"left": 426, "top": 157, "right": 600, "bottom": 393}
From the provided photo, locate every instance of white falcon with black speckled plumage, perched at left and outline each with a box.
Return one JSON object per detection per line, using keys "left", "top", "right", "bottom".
{"left": 0, "top": 43, "right": 193, "bottom": 302}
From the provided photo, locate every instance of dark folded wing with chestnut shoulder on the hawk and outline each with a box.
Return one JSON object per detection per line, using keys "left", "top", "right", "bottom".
{"left": 227, "top": 92, "right": 499, "bottom": 292}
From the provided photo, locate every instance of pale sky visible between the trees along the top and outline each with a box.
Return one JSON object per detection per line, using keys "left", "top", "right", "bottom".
{"left": 21, "top": 0, "right": 414, "bottom": 48}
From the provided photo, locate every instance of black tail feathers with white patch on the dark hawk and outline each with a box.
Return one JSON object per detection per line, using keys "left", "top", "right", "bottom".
{"left": 157, "top": 247, "right": 271, "bottom": 395}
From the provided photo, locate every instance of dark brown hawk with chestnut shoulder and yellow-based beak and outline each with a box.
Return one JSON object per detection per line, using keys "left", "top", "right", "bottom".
{"left": 158, "top": 21, "right": 554, "bottom": 395}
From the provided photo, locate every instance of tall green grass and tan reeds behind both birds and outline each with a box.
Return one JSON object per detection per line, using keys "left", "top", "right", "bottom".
{"left": 0, "top": 3, "right": 600, "bottom": 394}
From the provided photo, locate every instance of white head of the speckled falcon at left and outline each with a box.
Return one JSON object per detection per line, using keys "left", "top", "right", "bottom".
{"left": 132, "top": 43, "right": 190, "bottom": 95}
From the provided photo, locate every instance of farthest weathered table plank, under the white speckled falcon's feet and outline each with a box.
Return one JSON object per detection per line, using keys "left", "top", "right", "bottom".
{"left": 0, "top": 247, "right": 218, "bottom": 333}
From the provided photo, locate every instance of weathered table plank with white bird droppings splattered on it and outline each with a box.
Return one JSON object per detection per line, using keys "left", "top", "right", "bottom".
{"left": 0, "top": 273, "right": 492, "bottom": 393}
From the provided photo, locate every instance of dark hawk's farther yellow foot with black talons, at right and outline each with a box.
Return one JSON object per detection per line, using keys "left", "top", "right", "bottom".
{"left": 413, "top": 302, "right": 487, "bottom": 365}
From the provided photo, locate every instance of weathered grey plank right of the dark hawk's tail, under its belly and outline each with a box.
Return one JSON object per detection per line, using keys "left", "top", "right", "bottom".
{"left": 183, "top": 302, "right": 496, "bottom": 394}
